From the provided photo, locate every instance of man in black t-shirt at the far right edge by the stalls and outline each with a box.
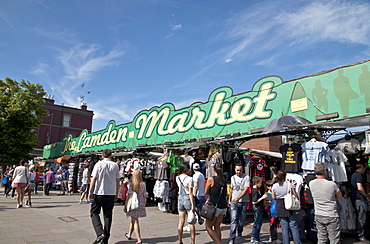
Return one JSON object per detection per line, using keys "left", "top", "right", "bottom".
{"left": 351, "top": 164, "right": 370, "bottom": 242}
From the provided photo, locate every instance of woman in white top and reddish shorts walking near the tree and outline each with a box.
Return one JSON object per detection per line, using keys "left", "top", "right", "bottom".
{"left": 12, "top": 159, "right": 29, "bottom": 208}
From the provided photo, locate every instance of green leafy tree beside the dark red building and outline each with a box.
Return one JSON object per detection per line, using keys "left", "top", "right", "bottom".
{"left": 0, "top": 78, "right": 48, "bottom": 164}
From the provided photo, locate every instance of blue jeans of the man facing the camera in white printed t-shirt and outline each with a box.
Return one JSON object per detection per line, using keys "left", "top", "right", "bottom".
{"left": 230, "top": 202, "right": 248, "bottom": 242}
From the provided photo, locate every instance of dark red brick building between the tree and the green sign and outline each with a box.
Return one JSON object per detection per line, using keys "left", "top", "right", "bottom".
{"left": 33, "top": 95, "right": 94, "bottom": 157}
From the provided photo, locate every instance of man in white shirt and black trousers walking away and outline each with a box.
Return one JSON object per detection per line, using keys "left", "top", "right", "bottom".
{"left": 89, "top": 149, "right": 120, "bottom": 244}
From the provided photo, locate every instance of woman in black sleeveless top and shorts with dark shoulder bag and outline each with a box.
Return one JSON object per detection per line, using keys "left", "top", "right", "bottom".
{"left": 205, "top": 163, "right": 227, "bottom": 244}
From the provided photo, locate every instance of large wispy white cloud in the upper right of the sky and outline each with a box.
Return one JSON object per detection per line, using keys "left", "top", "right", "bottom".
{"left": 209, "top": 0, "right": 370, "bottom": 65}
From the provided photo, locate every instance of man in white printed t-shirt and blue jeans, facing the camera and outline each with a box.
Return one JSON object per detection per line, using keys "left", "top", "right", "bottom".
{"left": 229, "top": 163, "right": 250, "bottom": 244}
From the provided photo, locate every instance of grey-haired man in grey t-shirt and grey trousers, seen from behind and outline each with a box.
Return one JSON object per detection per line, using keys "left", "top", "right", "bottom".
{"left": 309, "top": 162, "right": 342, "bottom": 244}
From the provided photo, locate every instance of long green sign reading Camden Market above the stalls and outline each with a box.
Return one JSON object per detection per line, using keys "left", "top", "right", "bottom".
{"left": 43, "top": 60, "right": 370, "bottom": 158}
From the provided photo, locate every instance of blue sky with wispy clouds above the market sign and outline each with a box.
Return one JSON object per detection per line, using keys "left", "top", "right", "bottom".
{"left": 0, "top": 0, "right": 370, "bottom": 131}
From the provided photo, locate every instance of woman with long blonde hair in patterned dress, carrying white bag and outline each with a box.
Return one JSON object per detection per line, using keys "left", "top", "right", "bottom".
{"left": 124, "top": 169, "right": 148, "bottom": 244}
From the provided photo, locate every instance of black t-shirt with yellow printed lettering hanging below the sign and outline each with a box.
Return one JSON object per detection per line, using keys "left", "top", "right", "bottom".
{"left": 279, "top": 143, "right": 302, "bottom": 173}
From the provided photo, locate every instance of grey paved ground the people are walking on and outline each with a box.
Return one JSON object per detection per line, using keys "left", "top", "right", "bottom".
{"left": 0, "top": 188, "right": 364, "bottom": 244}
